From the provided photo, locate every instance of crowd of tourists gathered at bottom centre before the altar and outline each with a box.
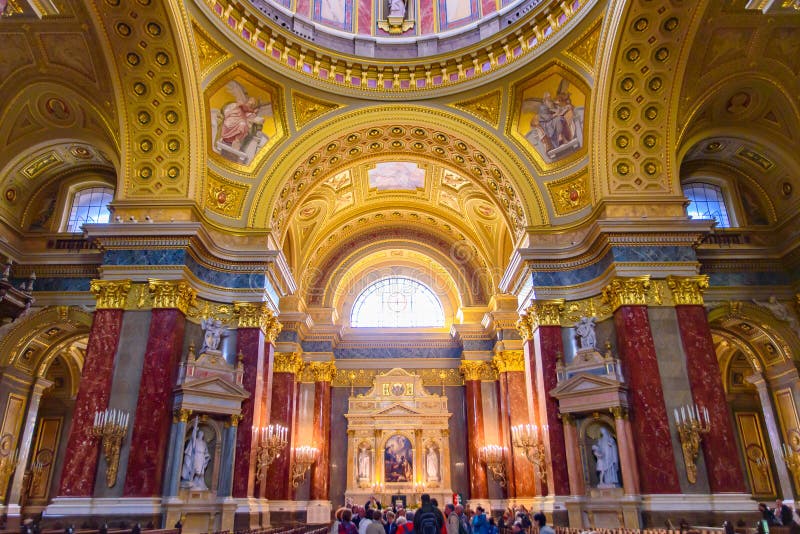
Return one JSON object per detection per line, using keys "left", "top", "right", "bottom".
{"left": 330, "top": 493, "right": 555, "bottom": 534}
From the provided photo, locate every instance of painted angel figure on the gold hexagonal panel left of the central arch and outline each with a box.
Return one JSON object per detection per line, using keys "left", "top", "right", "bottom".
{"left": 211, "top": 80, "right": 273, "bottom": 165}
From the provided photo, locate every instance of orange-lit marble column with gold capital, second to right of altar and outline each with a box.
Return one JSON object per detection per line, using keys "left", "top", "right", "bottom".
{"left": 494, "top": 350, "right": 536, "bottom": 498}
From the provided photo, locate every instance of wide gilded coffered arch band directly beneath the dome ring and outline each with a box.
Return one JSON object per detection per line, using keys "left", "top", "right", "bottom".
{"left": 248, "top": 105, "right": 548, "bottom": 236}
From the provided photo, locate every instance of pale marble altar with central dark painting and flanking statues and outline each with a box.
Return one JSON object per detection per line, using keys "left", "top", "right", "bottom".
{"left": 345, "top": 369, "right": 452, "bottom": 506}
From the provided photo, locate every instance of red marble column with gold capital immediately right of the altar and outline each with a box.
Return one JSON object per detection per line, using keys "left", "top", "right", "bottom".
{"left": 461, "top": 360, "right": 489, "bottom": 501}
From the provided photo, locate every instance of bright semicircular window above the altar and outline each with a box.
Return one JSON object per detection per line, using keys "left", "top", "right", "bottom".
{"left": 350, "top": 276, "right": 444, "bottom": 328}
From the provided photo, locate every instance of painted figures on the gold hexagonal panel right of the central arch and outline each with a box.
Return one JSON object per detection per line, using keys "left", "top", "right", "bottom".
{"left": 521, "top": 78, "right": 584, "bottom": 163}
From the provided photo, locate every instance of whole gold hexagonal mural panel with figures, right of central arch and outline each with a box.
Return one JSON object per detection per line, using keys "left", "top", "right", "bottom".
{"left": 510, "top": 67, "right": 588, "bottom": 169}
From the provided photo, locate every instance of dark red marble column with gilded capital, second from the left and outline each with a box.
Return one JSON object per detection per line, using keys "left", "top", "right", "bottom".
{"left": 122, "top": 280, "right": 195, "bottom": 497}
